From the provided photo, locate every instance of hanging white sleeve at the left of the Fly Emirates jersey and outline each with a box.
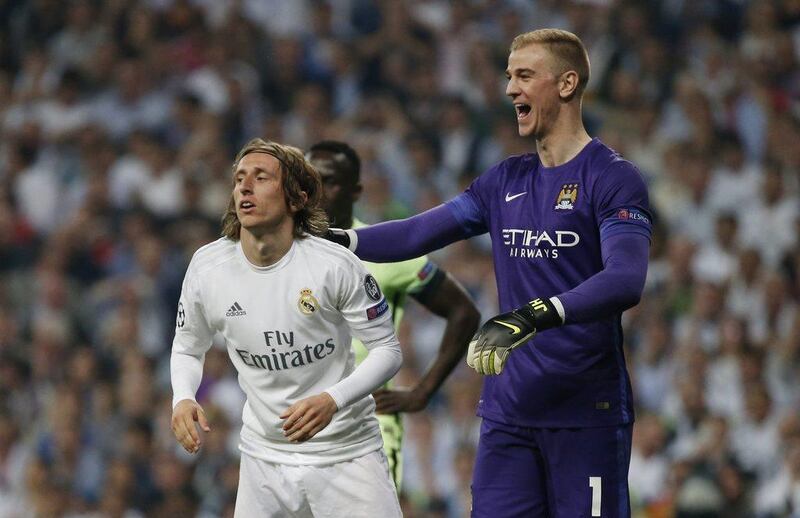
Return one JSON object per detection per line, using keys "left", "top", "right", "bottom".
{"left": 170, "top": 258, "right": 213, "bottom": 408}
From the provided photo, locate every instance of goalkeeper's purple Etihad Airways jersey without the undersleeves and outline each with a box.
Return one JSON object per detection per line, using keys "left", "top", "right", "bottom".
{"left": 448, "top": 139, "right": 651, "bottom": 427}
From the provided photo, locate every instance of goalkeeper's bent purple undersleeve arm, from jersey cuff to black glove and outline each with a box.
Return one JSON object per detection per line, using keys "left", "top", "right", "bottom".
{"left": 558, "top": 233, "right": 650, "bottom": 324}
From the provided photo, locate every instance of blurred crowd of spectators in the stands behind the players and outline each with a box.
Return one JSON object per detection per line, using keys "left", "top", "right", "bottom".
{"left": 0, "top": 0, "right": 800, "bottom": 518}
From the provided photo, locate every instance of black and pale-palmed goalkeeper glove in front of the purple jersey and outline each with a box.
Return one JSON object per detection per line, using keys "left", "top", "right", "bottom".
{"left": 467, "top": 299, "right": 562, "bottom": 375}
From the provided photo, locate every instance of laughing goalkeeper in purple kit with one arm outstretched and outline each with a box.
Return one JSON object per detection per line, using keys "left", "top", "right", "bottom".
{"left": 324, "top": 29, "right": 651, "bottom": 518}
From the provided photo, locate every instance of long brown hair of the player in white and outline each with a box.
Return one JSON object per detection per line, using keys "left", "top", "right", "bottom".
{"left": 222, "top": 138, "right": 328, "bottom": 241}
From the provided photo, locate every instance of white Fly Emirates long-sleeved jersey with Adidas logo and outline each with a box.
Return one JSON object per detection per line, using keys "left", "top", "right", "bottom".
{"left": 170, "top": 236, "right": 402, "bottom": 464}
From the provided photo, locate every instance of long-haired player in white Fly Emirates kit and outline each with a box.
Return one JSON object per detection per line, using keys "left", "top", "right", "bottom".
{"left": 170, "top": 139, "right": 402, "bottom": 517}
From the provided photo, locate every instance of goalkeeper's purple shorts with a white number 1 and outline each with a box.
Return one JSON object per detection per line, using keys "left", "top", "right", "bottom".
{"left": 472, "top": 419, "right": 633, "bottom": 518}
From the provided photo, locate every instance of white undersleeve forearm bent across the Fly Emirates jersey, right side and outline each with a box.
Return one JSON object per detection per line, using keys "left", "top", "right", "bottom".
{"left": 325, "top": 334, "right": 403, "bottom": 410}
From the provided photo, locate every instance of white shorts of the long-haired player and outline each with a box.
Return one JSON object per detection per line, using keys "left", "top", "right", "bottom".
{"left": 234, "top": 450, "right": 402, "bottom": 518}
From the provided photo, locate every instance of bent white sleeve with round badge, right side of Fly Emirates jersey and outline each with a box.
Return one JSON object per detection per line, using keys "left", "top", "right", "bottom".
{"left": 326, "top": 256, "right": 403, "bottom": 409}
